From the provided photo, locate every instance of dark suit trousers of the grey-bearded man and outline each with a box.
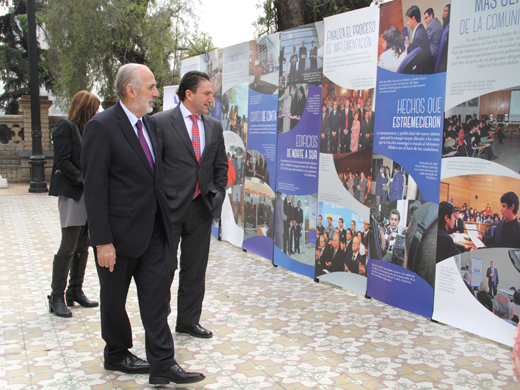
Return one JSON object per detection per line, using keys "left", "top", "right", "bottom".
{"left": 94, "top": 215, "right": 175, "bottom": 376}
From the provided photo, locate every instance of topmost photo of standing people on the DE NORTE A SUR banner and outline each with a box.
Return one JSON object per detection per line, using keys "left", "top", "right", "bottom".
{"left": 278, "top": 22, "right": 323, "bottom": 88}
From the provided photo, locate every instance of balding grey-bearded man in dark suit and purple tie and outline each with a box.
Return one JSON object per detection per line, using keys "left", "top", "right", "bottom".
{"left": 81, "top": 64, "right": 204, "bottom": 384}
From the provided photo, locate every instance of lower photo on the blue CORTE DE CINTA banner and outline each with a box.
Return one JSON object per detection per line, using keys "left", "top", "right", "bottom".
{"left": 244, "top": 178, "right": 275, "bottom": 240}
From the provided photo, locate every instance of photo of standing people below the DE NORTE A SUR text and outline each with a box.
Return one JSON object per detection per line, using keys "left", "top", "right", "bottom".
{"left": 269, "top": 192, "right": 318, "bottom": 265}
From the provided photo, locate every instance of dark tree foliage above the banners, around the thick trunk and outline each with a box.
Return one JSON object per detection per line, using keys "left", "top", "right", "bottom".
{"left": 253, "top": 0, "right": 372, "bottom": 36}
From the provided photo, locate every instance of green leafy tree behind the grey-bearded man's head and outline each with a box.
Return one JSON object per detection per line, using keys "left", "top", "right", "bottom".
{"left": 45, "top": 0, "right": 193, "bottom": 106}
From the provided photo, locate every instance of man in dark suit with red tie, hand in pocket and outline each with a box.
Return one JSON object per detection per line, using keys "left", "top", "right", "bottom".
{"left": 152, "top": 71, "right": 228, "bottom": 338}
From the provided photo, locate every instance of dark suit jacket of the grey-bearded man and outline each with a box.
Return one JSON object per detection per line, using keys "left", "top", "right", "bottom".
{"left": 81, "top": 102, "right": 172, "bottom": 257}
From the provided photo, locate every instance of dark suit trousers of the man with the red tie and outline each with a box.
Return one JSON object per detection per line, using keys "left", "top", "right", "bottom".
{"left": 169, "top": 195, "right": 213, "bottom": 325}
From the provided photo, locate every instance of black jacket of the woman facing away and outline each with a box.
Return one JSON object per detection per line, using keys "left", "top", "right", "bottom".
{"left": 49, "top": 119, "right": 83, "bottom": 200}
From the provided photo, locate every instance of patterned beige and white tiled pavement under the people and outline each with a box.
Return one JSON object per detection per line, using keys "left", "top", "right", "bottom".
{"left": 0, "top": 190, "right": 520, "bottom": 390}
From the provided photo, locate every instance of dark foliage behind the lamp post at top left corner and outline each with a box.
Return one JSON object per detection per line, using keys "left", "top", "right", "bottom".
{"left": 0, "top": 0, "right": 53, "bottom": 114}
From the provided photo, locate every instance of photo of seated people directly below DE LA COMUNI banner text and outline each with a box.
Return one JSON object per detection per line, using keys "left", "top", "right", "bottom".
{"left": 442, "top": 87, "right": 520, "bottom": 172}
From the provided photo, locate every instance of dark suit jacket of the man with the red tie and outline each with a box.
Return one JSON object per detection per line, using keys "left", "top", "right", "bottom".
{"left": 152, "top": 106, "right": 228, "bottom": 222}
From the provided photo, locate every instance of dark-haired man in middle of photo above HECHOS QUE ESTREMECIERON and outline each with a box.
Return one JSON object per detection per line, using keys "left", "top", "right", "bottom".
{"left": 406, "top": 5, "right": 433, "bottom": 74}
